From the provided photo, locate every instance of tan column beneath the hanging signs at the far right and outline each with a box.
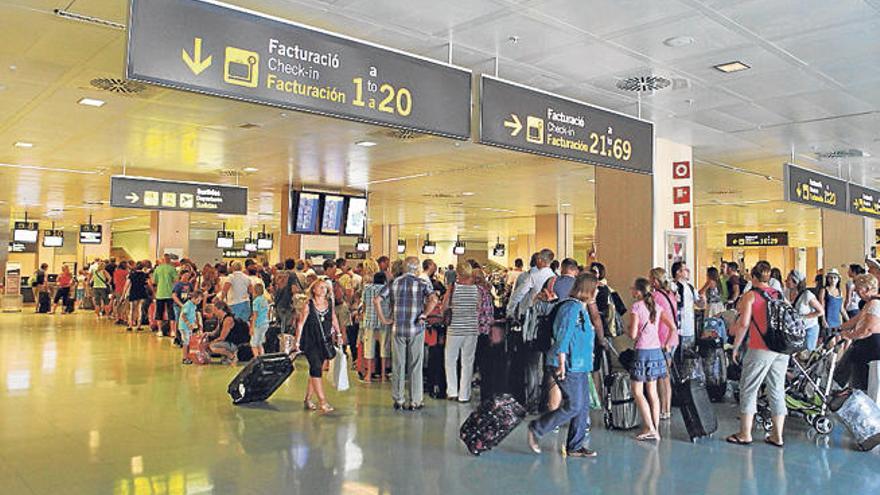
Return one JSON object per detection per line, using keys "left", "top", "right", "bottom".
{"left": 822, "top": 210, "right": 873, "bottom": 273}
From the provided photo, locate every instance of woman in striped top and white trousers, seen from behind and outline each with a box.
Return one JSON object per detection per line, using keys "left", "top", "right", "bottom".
{"left": 443, "top": 263, "right": 480, "bottom": 402}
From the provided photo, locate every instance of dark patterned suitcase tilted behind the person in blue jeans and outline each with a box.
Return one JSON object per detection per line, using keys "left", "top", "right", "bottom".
{"left": 458, "top": 394, "right": 526, "bottom": 455}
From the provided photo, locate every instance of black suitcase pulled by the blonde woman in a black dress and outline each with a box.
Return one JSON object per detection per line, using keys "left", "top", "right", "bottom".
{"left": 227, "top": 352, "right": 293, "bottom": 404}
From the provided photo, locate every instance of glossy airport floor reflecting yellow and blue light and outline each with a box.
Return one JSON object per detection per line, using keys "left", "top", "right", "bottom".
{"left": 0, "top": 313, "right": 880, "bottom": 495}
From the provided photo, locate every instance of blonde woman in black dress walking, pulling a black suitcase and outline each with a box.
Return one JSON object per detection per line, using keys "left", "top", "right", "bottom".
{"left": 295, "top": 280, "right": 340, "bottom": 413}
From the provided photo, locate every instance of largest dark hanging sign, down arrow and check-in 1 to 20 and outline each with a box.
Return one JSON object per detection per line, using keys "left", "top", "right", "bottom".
{"left": 127, "top": 0, "right": 471, "bottom": 139}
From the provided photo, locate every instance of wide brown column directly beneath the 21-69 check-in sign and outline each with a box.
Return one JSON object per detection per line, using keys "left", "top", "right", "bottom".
{"left": 596, "top": 167, "right": 654, "bottom": 306}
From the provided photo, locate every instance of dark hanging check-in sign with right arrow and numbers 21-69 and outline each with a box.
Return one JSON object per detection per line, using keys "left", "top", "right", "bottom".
{"left": 480, "top": 75, "right": 654, "bottom": 174}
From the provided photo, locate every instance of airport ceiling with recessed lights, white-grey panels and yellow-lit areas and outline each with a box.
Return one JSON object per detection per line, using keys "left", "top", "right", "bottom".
{"left": 0, "top": 0, "right": 880, "bottom": 245}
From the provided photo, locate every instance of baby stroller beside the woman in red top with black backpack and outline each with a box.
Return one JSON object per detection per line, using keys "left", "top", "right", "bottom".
{"left": 755, "top": 334, "right": 843, "bottom": 435}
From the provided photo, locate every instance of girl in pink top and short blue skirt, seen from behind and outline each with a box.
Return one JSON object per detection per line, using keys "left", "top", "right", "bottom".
{"left": 629, "top": 278, "right": 675, "bottom": 440}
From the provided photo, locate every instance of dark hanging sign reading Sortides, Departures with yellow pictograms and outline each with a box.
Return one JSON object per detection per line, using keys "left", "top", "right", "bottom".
{"left": 110, "top": 175, "right": 247, "bottom": 215}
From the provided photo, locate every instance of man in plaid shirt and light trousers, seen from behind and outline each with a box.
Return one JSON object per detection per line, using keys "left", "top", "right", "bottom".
{"left": 373, "top": 256, "right": 437, "bottom": 410}
